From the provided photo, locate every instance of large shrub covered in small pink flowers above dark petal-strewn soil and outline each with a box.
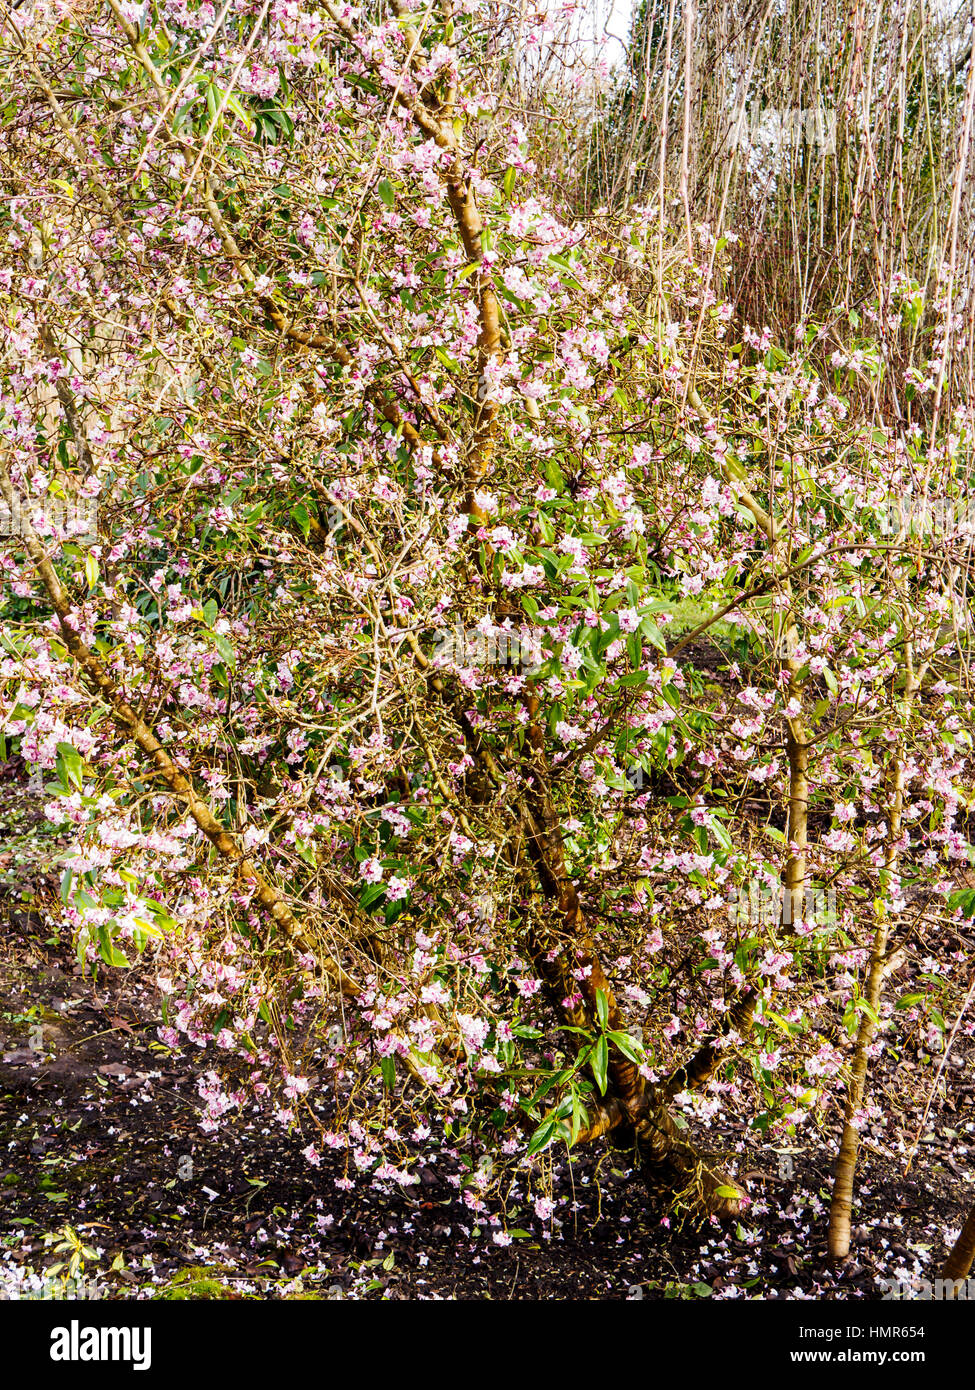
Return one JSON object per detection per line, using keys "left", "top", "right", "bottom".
{"left": 0, "top": 0, "right": 972, "bottom": 1245}
